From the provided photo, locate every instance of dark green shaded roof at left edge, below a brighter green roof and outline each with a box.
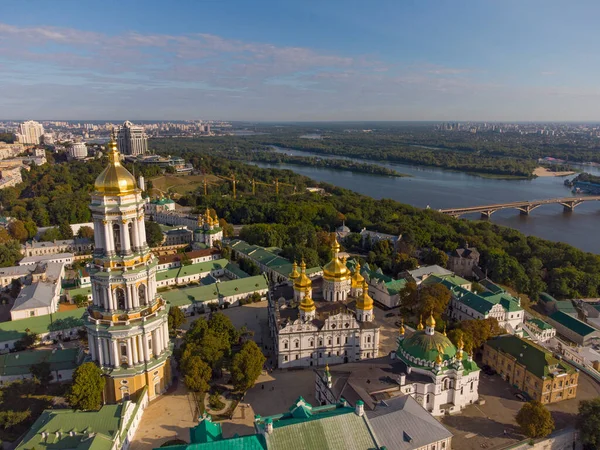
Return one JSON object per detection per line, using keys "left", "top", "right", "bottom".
{"left": 0, "top": 348, "right": 79, "bottom": 376}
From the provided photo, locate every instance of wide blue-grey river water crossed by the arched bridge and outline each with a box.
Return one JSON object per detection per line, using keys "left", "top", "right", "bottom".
{"left": 255, "top": 148, "right": 600, "bottom": 254}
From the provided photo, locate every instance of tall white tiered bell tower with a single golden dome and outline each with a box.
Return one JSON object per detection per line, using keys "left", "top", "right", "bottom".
{"left": 86, "top": 132, "right": 171, "bottom": 403}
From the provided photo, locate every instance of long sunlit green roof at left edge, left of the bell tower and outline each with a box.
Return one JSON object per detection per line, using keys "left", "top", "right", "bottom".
{"left": 0, "top": 308, "right": 86, "bottom": 342}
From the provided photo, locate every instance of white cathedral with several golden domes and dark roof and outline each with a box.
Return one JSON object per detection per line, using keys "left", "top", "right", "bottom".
{"left": 268, "top": 236, "right": 379, "bottom": 368}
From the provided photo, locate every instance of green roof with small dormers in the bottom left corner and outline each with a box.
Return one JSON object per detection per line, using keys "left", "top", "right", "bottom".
{"left": 16, "top": 404, "right": 123, "bottom": 450}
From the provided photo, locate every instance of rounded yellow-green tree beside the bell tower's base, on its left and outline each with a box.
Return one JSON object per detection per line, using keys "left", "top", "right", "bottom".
{"left": 66, "top": 362, "right": 106, "bottom": 410}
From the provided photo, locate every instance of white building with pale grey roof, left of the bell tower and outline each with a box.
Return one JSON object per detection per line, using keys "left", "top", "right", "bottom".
{"left": 10, "top": 262, "right": 65, "bottom": 320}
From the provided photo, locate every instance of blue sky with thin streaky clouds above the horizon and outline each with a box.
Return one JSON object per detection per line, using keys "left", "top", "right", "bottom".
{"left": 0, "top": 0, "right": 600, "bottom": 121}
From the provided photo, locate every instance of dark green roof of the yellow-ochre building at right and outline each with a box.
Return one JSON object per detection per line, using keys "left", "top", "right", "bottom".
{"left": 486, "top": 334, "right": 575, "bottom": 378}
